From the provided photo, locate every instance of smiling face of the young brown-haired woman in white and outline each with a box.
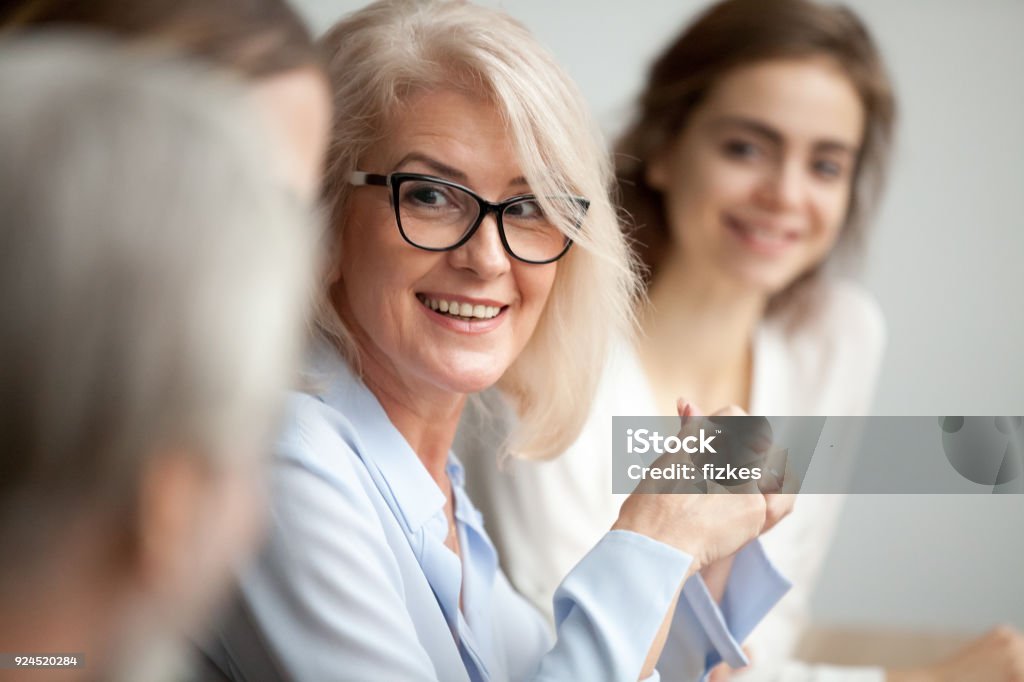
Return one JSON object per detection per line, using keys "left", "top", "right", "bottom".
{"left": 647, "top": 58, "right": 864, "bottom": 296}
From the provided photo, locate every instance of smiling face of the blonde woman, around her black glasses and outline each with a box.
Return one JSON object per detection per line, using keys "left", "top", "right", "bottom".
{"left": 332, "top": 91, "right": 557, "bottom": 393}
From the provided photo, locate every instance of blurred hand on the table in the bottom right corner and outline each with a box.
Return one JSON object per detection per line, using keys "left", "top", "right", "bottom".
{"left": 886, "top": 626, "right": 1024, "bottom": 682}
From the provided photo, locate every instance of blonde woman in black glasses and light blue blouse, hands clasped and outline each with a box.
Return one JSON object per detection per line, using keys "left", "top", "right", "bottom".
{"left": 197, "top": 0, "right": 784, "bottom": 681}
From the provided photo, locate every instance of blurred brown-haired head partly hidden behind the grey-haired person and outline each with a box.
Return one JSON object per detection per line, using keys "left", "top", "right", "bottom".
{"left": 0, "top": 0, "right": 330, "bottom": 198}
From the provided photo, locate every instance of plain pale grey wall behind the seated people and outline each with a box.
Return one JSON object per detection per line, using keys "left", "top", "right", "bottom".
{"left": 293, "top": 0, "right": 1024, "bottom": 632}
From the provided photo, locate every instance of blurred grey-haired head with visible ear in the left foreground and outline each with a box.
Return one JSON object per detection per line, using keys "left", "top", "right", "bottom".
{"left": 0, "top": 38, "right": 315, "bottom": 679}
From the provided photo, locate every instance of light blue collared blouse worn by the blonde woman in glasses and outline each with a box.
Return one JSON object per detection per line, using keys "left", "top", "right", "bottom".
{"left": 203, "top": 349, "right": 788, "bottom": 682}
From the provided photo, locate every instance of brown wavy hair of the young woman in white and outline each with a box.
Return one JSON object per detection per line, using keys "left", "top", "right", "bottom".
{"left": 615, "top": 0, "right": 896, "bottom": 310}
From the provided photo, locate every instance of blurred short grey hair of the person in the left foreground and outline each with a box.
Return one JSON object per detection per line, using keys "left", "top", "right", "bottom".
{"left": 0, "top": 38, "right": 315, "bottom": 569}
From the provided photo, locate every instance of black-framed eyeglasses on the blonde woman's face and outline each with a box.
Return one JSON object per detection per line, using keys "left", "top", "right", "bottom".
{"left": 349, "top": 171, "right": 590, "bottom": 265}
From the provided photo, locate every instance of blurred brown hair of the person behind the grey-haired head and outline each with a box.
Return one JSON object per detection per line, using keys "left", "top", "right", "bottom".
{"left": 0, "top": 0, "right": 321, "bottom": 79}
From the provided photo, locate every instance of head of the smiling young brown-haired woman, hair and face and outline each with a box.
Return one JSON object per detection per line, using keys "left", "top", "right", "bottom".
{"left": 616, "top": 0, "right": 895, "bottom": 307}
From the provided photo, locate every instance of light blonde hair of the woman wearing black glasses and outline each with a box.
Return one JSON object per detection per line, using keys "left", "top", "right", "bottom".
{"left": 317, "top": 0, "right": 637, "bottom": 459}
